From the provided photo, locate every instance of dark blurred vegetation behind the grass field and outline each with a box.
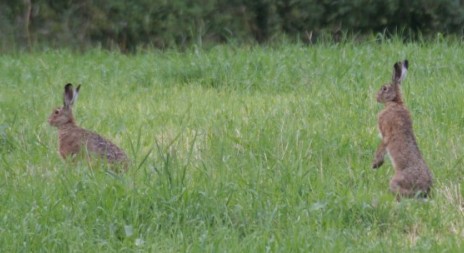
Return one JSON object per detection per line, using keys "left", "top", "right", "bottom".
{"left": 0, "top": 0, "right": 464, "bottom": 51}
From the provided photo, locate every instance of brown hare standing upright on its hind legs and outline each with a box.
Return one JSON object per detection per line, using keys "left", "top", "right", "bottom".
{"left": 372, "top": 60, "right": 432, "bottom": 199}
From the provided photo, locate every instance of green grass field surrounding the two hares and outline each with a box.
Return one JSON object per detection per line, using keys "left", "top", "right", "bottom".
{"left": 0, "top": 40, "right": 464, "bottom": 252}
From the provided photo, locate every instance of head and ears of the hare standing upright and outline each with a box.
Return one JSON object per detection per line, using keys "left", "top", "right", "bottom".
{"left": 377, "top": 60, "right": 408, "bottom": 103}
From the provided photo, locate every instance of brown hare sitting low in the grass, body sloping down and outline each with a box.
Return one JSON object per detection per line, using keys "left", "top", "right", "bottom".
{"left": 48, "top": 83, "right": 128, "bottom": 170}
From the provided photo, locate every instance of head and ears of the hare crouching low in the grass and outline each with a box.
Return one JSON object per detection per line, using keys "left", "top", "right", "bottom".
{"left": 48, "top": 83, "right": 81, "bottom": 127}
